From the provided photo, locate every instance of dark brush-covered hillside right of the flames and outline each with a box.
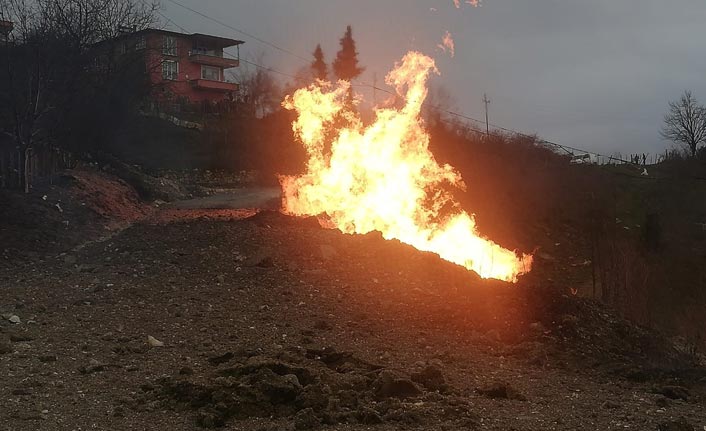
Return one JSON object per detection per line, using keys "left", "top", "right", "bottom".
{"left": 424, "top": 119, "right": 706, "bottom": 348}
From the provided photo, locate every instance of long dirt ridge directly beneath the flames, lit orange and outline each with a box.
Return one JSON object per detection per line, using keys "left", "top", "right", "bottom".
{"left": 236, "top": 212, "right": 695, "bottom": 379}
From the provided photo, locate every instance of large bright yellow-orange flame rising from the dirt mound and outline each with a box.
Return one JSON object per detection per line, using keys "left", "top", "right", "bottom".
{"left": 280, "top": 52, "right": 532, "bottom": 282}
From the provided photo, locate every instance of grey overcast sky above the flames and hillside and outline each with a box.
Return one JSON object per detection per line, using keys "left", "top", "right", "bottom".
{"left": 162, "top": 0, "right": 706, "bottom": 154}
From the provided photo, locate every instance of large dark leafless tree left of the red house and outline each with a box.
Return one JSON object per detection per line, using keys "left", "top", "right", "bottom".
{"left": 0, "top": 0, "right": 158, "bottom": 192}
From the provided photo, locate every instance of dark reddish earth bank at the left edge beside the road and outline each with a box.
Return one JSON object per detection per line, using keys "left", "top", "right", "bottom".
{"left": 0, "top": 166, "right": 150, "bottom": 265}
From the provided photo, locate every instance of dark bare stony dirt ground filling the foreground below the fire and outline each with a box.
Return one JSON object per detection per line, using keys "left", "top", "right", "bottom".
{"left": 0, "top": 204, "right": 706, "bottom": 430}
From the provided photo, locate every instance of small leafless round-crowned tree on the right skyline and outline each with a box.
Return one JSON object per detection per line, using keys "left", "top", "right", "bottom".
{"left": 660, "top": 90, "right": 706, "bottom": 157}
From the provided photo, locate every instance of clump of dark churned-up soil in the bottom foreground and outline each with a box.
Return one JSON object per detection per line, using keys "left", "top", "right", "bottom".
{"left": 154, "top": 348, "right": 476, "bottom": 429}
